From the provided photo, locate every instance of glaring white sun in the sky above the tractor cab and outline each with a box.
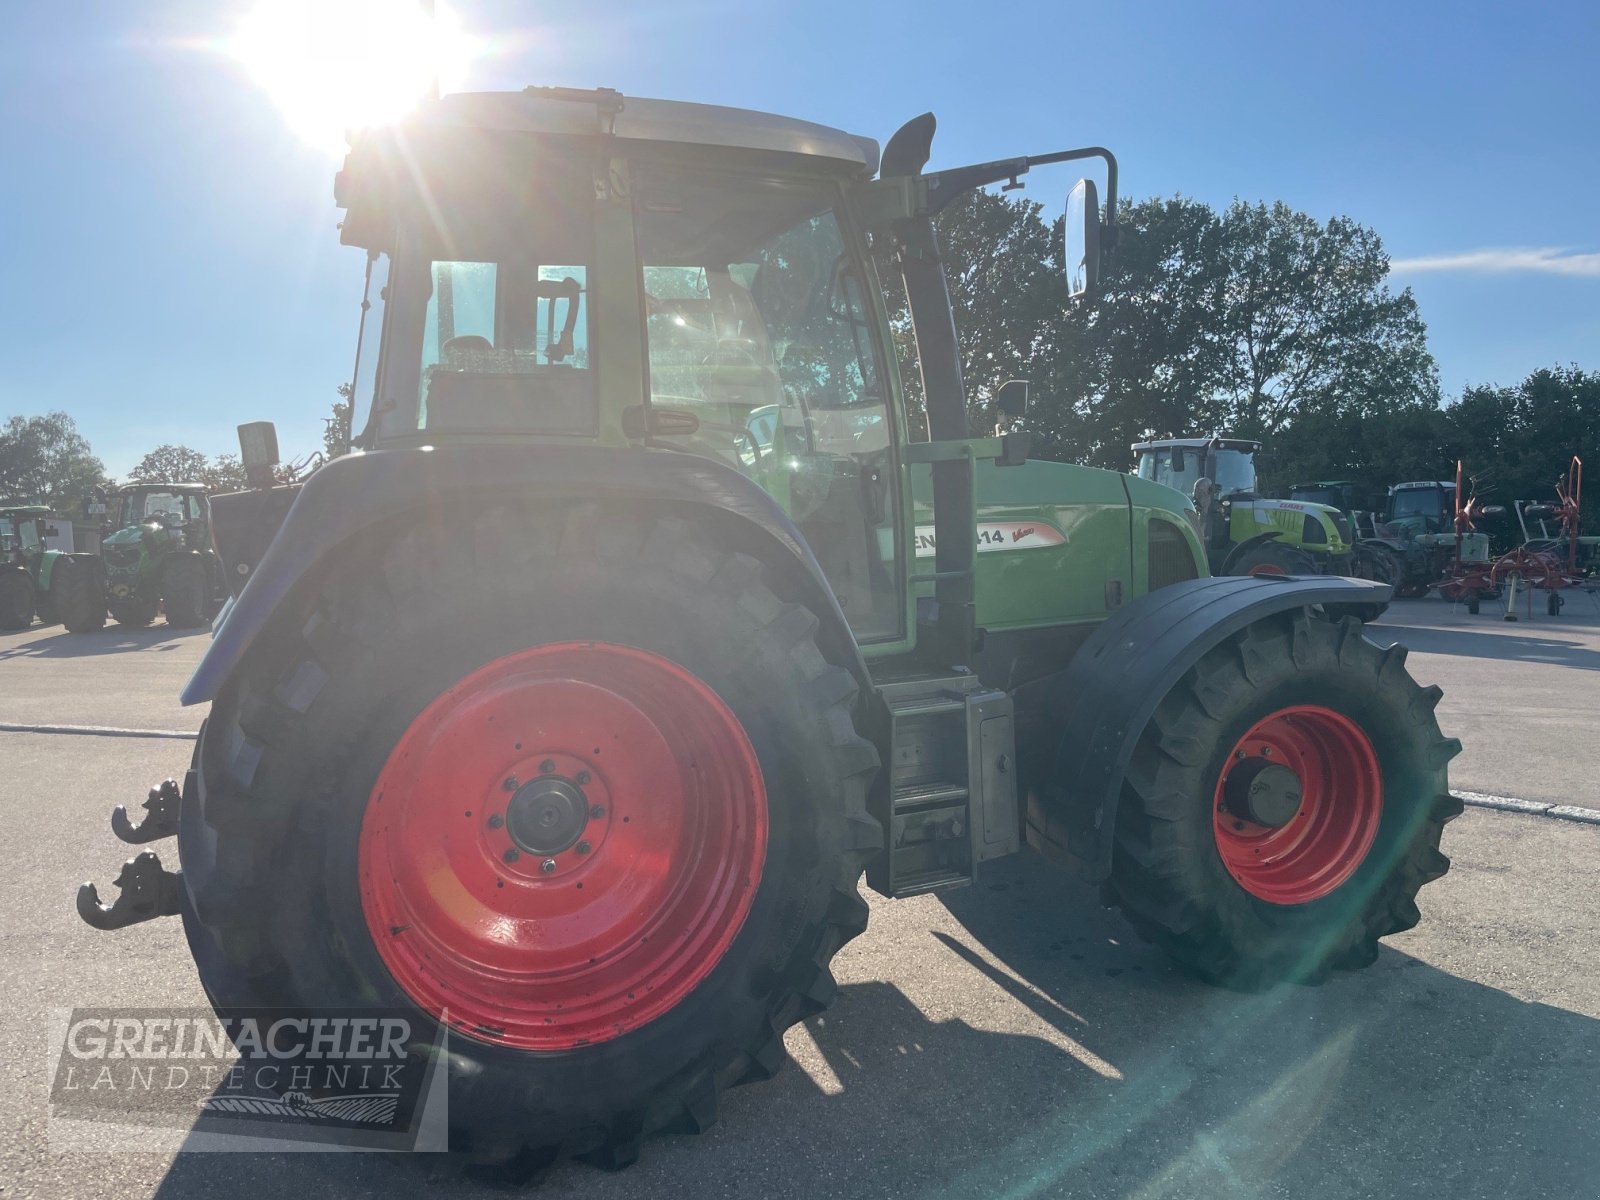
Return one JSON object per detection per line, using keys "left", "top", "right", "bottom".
{"left": 227, "top": 0, "right": 477, "bottom": 152}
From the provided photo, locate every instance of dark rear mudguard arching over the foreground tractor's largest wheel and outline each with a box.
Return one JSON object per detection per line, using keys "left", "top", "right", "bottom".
{"left": 181, "top": 443, "right": 867, "bottom": 704}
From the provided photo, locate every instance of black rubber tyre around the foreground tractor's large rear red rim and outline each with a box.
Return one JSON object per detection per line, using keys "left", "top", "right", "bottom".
{"left": 179, "top": 506, "right": 882, "bottom": 1171}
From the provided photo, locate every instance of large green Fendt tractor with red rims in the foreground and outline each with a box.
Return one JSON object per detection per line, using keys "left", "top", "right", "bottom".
{"left": 78, "top": 88, "right": 1459, "bottom": 1171}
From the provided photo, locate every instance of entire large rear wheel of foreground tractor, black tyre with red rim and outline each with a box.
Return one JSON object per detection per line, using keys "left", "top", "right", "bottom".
{"left": 179, "top": 506, "right": 882, "bottom": 1170}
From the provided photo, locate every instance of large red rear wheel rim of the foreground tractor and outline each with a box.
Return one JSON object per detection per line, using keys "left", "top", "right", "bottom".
{"left": 358, "top": 642, "right": 766, "bottom": 1050}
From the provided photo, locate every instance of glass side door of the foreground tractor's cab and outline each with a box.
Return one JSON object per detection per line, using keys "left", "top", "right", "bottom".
{"left": 635, "top": 166, "right": 901, "bottom": 637}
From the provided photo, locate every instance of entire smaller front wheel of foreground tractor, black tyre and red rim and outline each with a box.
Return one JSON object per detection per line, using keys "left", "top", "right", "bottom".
{"left": 1109, "top": 613, "right": 1461, "bottom": 990}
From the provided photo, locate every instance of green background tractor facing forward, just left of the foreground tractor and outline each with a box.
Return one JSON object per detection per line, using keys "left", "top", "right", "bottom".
{"left": 101, "top": 483, "right": 227, "bottom": 629}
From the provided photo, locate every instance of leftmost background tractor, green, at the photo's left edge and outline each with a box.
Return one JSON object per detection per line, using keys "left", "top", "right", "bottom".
{"left": 0, "top": 504, "right": 106, "bottom": 634}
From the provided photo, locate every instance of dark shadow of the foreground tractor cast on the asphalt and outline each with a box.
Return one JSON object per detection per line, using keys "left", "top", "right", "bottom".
{"left": 158, "top": 861, "right": 1600, "bottom": 1200}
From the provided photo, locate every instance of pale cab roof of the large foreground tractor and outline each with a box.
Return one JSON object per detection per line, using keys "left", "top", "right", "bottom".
{"left": 408, "top": 88, "right": 878, "bottom": 176}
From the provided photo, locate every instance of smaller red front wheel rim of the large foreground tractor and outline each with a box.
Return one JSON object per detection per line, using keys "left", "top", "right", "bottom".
{"left": 1211, "top": 704, "right": 1384, "bottom": 904}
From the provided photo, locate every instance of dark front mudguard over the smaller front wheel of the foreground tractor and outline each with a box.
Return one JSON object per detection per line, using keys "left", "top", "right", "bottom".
{"left": 1018, "top": 574, "right": 1390, "bottom": 882}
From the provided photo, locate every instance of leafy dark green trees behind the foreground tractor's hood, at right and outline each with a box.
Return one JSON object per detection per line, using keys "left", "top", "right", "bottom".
{"left": 915, "top": 192, "right": 1600, "bottom": 526}
